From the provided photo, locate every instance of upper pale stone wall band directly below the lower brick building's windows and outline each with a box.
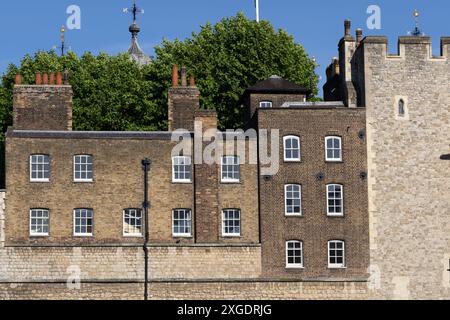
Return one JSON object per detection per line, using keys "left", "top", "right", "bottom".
{"left": 0, "top": 246, "right": 261, "bottom": 283}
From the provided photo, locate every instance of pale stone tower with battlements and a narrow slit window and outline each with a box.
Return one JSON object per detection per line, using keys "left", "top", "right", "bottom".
{"left": 355, "top": 37, "right": 450, "bottom": 299}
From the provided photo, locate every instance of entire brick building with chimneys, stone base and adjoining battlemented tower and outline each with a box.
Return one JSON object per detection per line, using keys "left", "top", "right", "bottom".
{"left": 0, "top": 21, "right": 450, "bottom": 299}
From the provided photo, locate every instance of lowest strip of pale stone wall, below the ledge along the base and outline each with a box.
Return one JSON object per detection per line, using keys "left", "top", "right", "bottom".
{"left": 0, "top": 281, "right": 370, "bottom": 300}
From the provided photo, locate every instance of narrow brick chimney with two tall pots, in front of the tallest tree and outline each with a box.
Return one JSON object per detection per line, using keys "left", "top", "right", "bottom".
{"left": 168, "top": 65, "right": 200, "bottom": 131}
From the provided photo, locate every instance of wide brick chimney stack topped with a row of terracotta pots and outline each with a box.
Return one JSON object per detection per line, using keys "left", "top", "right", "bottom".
{"left": 13, "top": 72, "right": 73, "bottom": 131}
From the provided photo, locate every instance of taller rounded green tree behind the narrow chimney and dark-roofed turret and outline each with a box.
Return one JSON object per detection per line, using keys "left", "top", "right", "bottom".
{"left": 148, "top": 13, "right": 318, "bottom": 129}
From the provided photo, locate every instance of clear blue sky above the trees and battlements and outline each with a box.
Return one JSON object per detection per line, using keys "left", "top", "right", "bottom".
{"left": 0, "top": 0, "right": 450, "bottom": 94}
